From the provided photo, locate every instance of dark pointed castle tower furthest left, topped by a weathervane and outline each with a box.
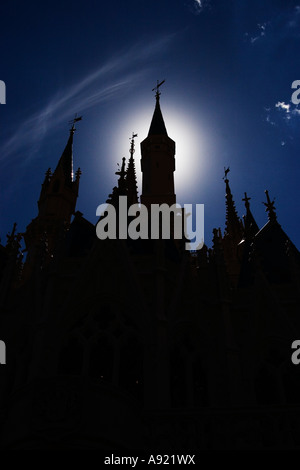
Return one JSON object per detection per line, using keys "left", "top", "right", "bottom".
{"left": 24, "top": 118, "right": 81, "bottom": 272}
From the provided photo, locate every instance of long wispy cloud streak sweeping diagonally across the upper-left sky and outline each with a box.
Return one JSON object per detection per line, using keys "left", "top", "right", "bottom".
{"left": 0, "top": 35, "right": 172, "bottom": 169}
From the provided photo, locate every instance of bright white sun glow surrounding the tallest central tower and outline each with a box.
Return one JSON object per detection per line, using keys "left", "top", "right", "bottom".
{"left": 111, "top": 100, "right": 207, "bottom": 203}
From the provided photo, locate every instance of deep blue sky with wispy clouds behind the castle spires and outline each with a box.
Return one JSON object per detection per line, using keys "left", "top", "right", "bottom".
{"left": 0, "top": 0, "right": 300, "bottom": 249}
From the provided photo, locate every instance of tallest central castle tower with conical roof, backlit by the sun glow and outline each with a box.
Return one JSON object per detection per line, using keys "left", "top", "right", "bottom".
{"left": 141, "top": 82, "right": 176, "bottom": 208}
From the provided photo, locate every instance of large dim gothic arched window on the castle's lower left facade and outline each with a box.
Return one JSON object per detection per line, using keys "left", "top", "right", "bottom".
{"left": 59, "top": 299, "right": 143, "bottom": 397}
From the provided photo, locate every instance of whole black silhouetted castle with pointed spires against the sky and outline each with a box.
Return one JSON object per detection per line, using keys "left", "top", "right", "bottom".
{"left": 0, "top": 88, "right": 300, "bottom": 452}
